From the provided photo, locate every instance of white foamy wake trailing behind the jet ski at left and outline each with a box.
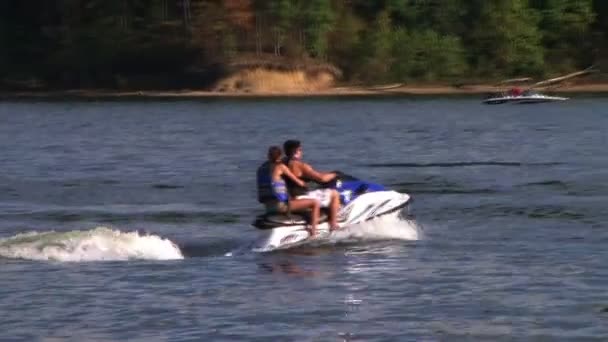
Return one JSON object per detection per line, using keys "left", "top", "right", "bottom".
{"left": 0, "top": 227, "right": 184, "bottom": 262}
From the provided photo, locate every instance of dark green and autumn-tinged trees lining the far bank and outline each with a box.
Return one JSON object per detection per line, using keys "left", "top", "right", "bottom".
{"left": 0, "top": 0, "right": 608, "bottom": 88}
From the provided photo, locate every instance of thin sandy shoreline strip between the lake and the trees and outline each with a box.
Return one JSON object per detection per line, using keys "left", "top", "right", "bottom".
{"left": 0, "top": 83, "right": 608, "bottom": 99}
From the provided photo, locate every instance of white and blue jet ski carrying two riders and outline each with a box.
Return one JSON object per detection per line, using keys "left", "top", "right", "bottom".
{"left": 253, "top": 172, "right": 411, "bottom": 251}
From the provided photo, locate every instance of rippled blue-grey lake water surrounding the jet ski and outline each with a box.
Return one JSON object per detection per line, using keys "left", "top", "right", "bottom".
{"left": 0, "top": 96, "right": 608, "bottom": 341}
